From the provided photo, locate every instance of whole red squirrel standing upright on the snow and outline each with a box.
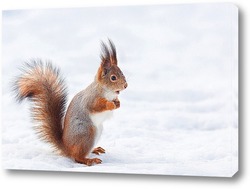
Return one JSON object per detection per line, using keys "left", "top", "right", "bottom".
{"left": 14, "top": 40, "right": 128, "bottom": 166}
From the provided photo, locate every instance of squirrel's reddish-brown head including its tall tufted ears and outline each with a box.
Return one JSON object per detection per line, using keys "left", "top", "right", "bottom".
{"left": 96, "top": 40, "right": 128, "bottom": 94}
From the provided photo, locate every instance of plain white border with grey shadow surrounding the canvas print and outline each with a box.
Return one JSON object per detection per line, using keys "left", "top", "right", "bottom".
{"left": 0, "top": 0, "right": 250, "bottom": 189}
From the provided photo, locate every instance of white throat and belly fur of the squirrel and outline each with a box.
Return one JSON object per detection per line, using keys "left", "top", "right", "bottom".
{"left": 90, "top": 91, "right": 117, "bottom": 144}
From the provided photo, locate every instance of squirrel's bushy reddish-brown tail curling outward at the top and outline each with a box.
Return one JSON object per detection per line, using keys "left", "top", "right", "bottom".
{"left": 14, "top": 60, "right": 67, "bottom": 153}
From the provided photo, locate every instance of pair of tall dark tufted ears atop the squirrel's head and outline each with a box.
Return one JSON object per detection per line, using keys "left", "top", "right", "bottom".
{"left": 101, "top": 39, "right": 117, "bottom": 69}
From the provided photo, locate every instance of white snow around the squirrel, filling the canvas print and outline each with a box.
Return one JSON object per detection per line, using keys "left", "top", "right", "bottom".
{"left": 2, "top": 4, "right": 238, "bottom": 176}
